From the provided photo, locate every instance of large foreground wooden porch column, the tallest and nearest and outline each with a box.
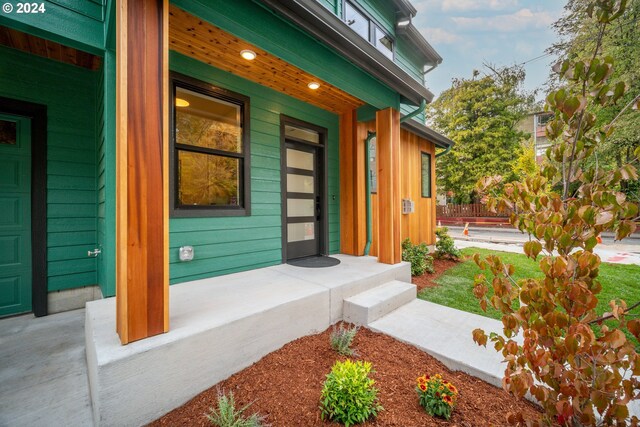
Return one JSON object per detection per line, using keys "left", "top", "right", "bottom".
{"left": 116, "top": 0, "right": 169, "bottom": 344}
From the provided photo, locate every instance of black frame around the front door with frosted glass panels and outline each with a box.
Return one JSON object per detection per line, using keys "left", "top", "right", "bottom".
{"left": 280, "top": 114, "right": 329, "bottom": 263}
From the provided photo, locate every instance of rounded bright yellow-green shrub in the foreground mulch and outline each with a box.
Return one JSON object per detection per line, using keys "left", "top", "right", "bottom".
{"left": 320, "top": 360, "right": 382, "bottom": 427}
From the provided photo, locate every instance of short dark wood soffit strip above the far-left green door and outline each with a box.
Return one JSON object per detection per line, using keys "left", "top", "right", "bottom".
{"left": 0, "top": 26, "right": 100, "bottom": 71}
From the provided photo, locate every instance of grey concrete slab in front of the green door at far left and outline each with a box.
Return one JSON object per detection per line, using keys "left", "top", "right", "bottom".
{"left": 0, "top": 310, "right": 93, "bottom": 427}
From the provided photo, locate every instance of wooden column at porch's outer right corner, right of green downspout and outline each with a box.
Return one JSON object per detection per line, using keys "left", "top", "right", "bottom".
{"left": 376, "top": 108, "right": 402, "bottom": 264}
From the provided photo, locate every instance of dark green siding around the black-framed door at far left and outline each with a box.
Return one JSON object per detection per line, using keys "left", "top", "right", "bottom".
{"left": 0, "top": 47, "right": 97, "bottom": 291}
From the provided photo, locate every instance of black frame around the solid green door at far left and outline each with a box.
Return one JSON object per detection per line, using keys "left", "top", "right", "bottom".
{"left": 0, "top": 96, "right": 48, "bottom": 317}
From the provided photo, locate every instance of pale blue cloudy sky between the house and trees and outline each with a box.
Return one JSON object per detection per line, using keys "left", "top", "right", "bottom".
{"left": 411, "top": 0, "right": 566, "bottom": 99}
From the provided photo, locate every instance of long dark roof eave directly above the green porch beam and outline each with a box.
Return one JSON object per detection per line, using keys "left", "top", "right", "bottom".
{"left": 260, "top": 0, "right": 434, "bottom": 105}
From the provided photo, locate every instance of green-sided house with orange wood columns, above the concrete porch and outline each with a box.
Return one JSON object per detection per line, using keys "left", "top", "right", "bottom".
{"left": 0, "top": 0, "right": 452, "bottom": 343}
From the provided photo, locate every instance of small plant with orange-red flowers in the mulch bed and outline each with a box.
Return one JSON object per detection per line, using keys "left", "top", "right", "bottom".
{"left": 416, "top": 374, "right": 458, "bottom": 420}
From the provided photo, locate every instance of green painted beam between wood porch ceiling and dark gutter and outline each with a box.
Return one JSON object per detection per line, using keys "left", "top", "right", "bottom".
{"left": 172, "top": 0, "right": 400, "bottom": 112}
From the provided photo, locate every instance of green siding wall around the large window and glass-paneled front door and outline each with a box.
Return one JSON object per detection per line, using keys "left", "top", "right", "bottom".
{"left": 169, "top": 52, "right": 340, "bottom": 283}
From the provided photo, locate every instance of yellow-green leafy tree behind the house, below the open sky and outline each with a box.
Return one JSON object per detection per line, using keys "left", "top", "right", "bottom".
{"left": 430, "top": 66, "right": 532, "bottom": 203}
